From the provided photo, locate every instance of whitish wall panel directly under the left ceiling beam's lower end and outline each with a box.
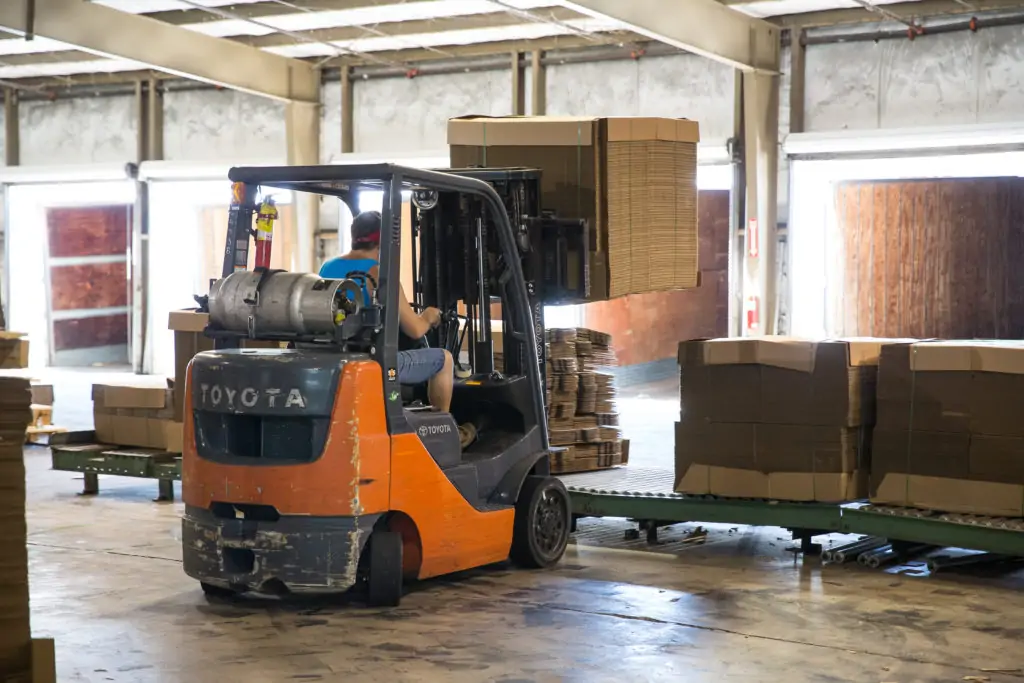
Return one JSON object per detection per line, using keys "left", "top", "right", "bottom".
{"left": 164, "top": 90, "right": 287, "bottom": 163}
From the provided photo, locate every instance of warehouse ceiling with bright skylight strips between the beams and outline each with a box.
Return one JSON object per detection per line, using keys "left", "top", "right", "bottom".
{"left": 0, "top": 0, "right": 1024, "bottom": 84}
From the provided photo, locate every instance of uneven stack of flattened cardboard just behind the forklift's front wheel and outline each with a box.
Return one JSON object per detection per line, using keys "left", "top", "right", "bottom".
{"left": 547, "top": 328, "right": 628, "bottom": 473}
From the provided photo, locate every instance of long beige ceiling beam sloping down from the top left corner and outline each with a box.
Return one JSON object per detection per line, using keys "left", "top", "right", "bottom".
{"left": 0, "top": 0, "right": 319, "bottom": 102}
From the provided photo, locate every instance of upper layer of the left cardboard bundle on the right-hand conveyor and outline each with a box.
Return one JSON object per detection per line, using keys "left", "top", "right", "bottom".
{"left": 679, "top": 337, "right": 884, "bottom": 427}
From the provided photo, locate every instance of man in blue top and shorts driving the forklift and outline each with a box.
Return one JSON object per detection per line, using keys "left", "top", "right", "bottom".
{"left": 319, "top": 211, "right": 476, "bottom": 450}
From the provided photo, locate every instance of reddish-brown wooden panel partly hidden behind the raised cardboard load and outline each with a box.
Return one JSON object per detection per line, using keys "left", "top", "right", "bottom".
{"left": 584, "top": 190, "right": 729, "bottom": 366}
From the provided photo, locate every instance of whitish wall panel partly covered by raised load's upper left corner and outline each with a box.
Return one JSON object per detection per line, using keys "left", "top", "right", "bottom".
{"left": 353, "top": 70, "right": 512, "bottom": 153}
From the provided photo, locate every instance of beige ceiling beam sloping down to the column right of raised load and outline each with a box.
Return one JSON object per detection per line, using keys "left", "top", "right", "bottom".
{"left": 561, "top": 0, "right": 780, "bottom": 74}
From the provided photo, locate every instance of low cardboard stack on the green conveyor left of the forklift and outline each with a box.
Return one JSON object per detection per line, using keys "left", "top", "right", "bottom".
{"left": 92, "top": 384, "right": 181, "bottom": 453}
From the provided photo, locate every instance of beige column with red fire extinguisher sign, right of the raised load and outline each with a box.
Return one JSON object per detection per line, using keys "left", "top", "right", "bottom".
{"left": 742, "top": 72, "right": 779, "bottom": 335}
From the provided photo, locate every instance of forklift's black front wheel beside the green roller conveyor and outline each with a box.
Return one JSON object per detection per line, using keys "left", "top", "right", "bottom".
{"left": 510, "top": 476, "right": 572, "bottom": 569}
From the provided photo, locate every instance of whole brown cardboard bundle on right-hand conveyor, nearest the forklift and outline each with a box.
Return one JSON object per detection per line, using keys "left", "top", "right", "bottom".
{"left": 676, "top": 337, "right": 882, "bottom": 502}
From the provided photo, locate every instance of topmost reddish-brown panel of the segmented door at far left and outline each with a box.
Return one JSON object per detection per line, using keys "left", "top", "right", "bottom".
{"left": 46, "top": 205, "right": 130, "bottom": 258}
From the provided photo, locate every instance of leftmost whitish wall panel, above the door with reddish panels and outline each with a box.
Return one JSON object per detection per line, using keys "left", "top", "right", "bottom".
{"left": 18, "top": 96, "right": 138, "bottom": 165}
